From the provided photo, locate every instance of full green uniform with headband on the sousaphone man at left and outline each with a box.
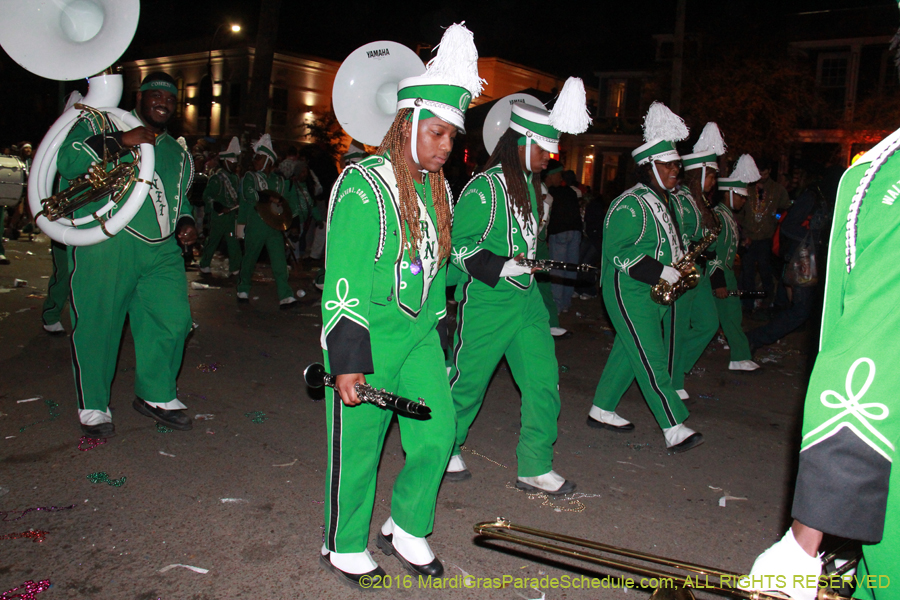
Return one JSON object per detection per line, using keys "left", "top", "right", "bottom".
{"left": 57, "top": 74, "right": 194, "bottom": 437}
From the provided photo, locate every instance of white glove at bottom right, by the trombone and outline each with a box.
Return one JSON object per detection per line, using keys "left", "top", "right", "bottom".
{"left": 741, "top": 529, "right": 822, "bottom": 600}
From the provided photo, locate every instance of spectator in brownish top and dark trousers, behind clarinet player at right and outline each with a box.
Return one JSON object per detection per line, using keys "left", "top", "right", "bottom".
{"left": 736, "top": 159, "right": 791, "bottom": 310}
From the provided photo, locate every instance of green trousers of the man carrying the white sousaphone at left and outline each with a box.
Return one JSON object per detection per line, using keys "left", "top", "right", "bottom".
{"left": 69, "top": 231, "right": 191, "bottom": 411}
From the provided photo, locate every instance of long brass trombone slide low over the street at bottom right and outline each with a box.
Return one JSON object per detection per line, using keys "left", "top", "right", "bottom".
{"left": 474, "top": 519, "right": 850, "bottom": 600}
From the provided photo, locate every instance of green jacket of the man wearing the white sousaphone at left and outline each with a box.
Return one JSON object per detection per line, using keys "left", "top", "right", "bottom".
{"left": 56, "top": 111, "right": 194, "bottom": 244}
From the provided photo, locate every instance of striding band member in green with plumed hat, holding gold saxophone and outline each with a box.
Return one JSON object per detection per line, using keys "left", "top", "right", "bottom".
{"left": 587, "top": 102, "right": 703, "bottom": 452}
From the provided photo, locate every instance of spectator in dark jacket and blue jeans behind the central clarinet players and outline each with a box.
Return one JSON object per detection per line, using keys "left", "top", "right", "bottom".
{"left": 544, "top": 160, "right": 584, "bottom": 313}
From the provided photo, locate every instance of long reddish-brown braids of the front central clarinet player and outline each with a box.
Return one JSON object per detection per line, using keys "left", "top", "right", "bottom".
{"left": 376, "top": 108, "right": 452, "bottom": 265}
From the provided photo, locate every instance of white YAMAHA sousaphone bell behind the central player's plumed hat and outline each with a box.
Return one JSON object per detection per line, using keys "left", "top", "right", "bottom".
{"left": 331, "top": 41, "right": 425, "bottom": 146}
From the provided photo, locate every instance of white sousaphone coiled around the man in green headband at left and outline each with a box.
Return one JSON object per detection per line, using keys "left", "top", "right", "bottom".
{"left": 0, "top": 0, "right": 154, "bottom": 246}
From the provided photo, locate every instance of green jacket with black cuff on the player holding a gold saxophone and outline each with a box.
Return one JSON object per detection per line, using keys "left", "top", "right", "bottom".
{"left": 600, "top": 184, "right": 684, "bottom": 294}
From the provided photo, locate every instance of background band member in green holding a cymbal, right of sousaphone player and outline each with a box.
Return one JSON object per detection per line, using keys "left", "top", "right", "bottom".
{"left": 237, "top": 133, "right": 306, "bottom": 308}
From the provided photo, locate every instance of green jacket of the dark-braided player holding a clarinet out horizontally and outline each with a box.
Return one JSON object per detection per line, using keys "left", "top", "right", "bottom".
{"left": 452, "top": 165, "right": 540, "bottom": 291}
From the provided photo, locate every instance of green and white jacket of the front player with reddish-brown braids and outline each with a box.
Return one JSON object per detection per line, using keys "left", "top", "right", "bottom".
{"left": 321, "top": 156, "right": 453, "bottom": 375}
